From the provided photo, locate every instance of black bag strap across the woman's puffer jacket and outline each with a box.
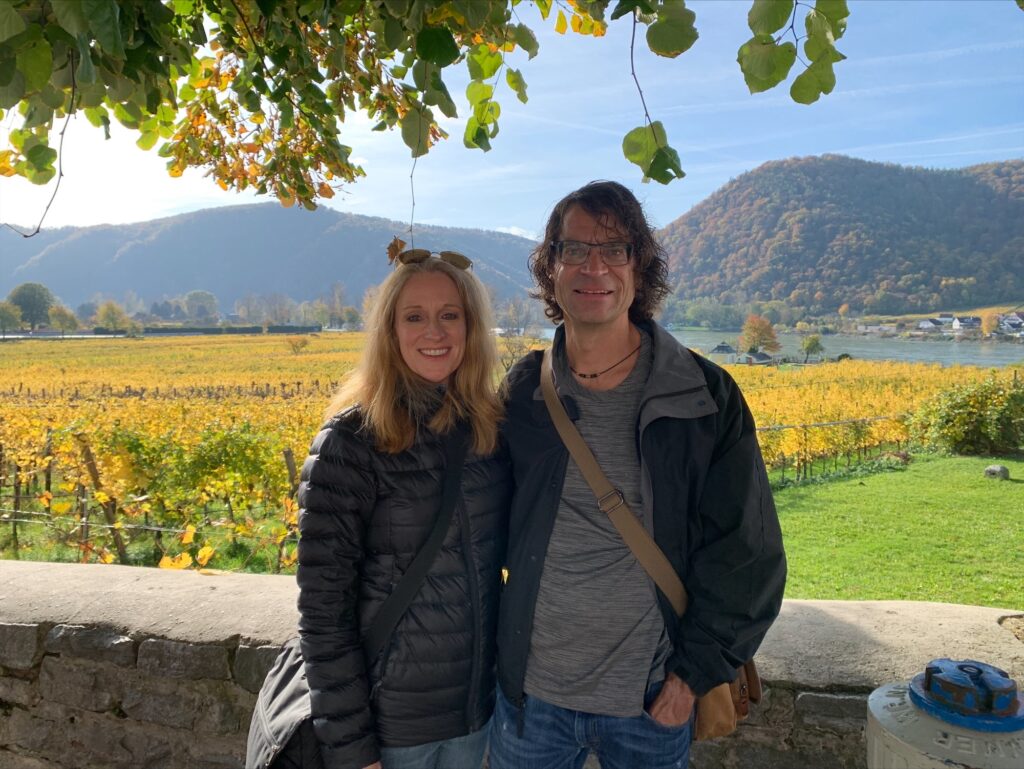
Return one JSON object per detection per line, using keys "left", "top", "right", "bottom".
{"left": 362, "top": 427, "right": 469, "bottom": 659}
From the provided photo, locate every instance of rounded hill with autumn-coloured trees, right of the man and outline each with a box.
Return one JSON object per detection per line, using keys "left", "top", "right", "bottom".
{"left": 660, "top": 155, "right": 1024, "bottom": 312}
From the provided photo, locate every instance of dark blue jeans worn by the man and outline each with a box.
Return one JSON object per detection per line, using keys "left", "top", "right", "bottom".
{"left": 487, "top": 683, "right": 692, "bottom": 769}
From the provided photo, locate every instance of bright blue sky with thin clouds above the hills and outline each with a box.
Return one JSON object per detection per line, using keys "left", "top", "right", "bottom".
{"left": 0, "top": 0, "right": 1024, "bottom": 236}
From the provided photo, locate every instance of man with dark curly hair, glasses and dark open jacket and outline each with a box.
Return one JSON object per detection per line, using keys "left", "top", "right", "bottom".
{"left": 489, "top": 181, "right": 785, "bottom": 769}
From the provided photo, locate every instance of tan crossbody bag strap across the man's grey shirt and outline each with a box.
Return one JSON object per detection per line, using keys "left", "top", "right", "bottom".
{"left": 541, "top": 348, "right": 687, "bottom": 616}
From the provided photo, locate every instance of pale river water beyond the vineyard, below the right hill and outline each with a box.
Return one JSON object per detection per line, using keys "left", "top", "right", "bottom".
{"left": 544, "top": 329, "right": 1024, "bottom": 367}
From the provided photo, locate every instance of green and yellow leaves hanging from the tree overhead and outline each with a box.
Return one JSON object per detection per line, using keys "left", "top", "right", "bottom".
{"left": 0, "top": 0, "right": 864, "bottom": 208}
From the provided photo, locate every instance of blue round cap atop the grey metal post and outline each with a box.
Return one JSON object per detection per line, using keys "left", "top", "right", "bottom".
{"left": 910, "top": 658, "right": 1024, "bottom": 732}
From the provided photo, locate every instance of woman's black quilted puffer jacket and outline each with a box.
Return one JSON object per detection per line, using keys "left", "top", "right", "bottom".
{"left": 298, "top": 409, "right": 510, "bottom": 769}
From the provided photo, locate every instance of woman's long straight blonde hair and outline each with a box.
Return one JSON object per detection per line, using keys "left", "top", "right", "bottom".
{"left": 327, "top": 257, "right": 503, "bottom": 455}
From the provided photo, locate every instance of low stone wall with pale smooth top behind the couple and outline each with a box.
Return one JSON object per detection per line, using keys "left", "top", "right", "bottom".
{"left": 0, "top": 561, "right": 1024, "bottom": 769}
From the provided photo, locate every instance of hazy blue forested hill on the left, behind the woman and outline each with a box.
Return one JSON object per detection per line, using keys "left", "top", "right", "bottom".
{"left": 0, "top": 203, "right": 535, "bottom": 312}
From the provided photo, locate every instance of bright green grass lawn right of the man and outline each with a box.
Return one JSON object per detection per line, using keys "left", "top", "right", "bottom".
{"left": 775, "top": 455, "right": 1024, "bottom": 609}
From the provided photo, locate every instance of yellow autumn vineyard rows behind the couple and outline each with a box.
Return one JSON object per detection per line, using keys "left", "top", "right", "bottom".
{"left": 0, "top": 334, "right": 1019, "bottom": 571}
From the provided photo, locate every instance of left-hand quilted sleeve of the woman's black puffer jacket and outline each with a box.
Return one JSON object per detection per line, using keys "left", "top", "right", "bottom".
{"left": 297, "top": 422, "right": 380, "bottom": 769}
